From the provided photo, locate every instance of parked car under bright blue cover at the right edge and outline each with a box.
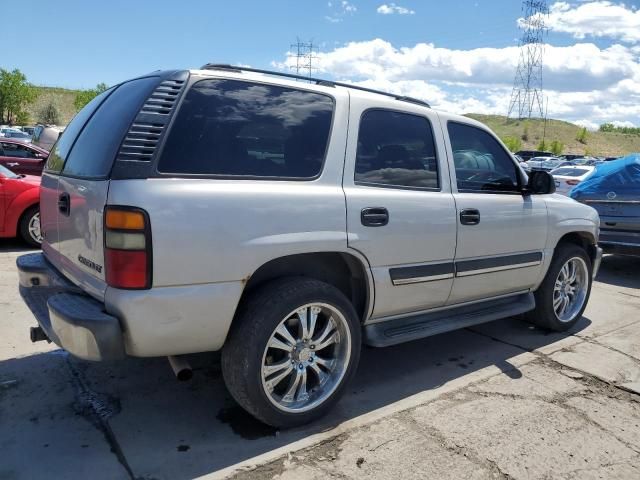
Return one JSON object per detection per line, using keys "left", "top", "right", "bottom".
{"left": 570, "top": 154, "right": 640, "bottom": 255}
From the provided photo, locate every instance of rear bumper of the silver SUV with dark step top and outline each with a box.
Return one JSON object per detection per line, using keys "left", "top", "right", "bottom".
{"left": 16, "top": 253, "right": 125, "bottom": 360}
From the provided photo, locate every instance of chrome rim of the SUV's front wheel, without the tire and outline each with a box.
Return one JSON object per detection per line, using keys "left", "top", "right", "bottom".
{"left": 553, "top": 257, "right": 589, "bottom": 322}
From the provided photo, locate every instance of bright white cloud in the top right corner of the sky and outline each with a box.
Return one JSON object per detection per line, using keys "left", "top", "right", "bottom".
{"left": 546, "top": 1, "right": 640, "bottom": 43}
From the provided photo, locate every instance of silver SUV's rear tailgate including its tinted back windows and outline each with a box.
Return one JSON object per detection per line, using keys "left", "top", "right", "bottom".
{"left": 42, "top": 77, "right": 159, "bottom": 300}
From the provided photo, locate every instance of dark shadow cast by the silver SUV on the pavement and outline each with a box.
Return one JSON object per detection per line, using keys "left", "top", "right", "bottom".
{"left": 0, "top": 318, "right": 591, "bottom": 479}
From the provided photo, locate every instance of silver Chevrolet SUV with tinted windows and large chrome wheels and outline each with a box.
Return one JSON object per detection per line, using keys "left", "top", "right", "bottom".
{"left": 18, "top": 65, "right": 601, "bottom": 427}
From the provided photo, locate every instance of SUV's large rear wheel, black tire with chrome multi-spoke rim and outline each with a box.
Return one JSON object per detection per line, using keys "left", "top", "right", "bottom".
{"left": 222, "top": 277, "right": 361, "bottom": 427}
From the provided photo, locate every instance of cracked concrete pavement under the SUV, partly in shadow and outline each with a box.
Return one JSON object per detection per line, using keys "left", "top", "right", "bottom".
{"left": 0, "top": 241, "right": 640, "bottom": 479}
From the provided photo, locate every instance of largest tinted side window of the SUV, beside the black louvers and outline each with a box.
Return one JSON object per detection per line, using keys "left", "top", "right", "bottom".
{"left": 158, "top": 79, "right": 334, "bottom": 179}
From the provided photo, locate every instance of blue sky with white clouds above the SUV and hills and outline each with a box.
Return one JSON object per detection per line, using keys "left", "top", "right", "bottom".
{"left": 0, "top": 0, "right": 640, "bottom": 129}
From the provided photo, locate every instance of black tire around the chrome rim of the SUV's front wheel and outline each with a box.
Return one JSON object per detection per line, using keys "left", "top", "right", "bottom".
{"left": 525, "top": 243, "right": 592, "bottom": 332}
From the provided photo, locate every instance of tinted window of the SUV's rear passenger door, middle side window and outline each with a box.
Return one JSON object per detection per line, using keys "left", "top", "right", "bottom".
{"left": 354, "top": 110, "right": 439, "bottom": 189}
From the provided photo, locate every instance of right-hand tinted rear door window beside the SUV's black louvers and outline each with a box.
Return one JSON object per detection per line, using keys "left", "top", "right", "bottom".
{"left": 62, "top": 77, "right": 158, "bottom": 178}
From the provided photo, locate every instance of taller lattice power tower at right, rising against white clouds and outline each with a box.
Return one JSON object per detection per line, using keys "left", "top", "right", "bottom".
{"left": 507, "top": 0, "right": 549, "bottom": 118}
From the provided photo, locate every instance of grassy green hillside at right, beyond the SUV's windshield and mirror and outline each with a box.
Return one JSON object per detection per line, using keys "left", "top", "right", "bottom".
{"left": 466, "top": 113, "right": 640, "bottom": 157}
